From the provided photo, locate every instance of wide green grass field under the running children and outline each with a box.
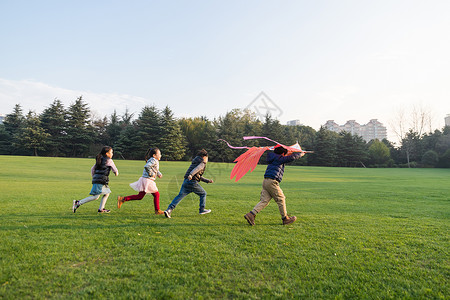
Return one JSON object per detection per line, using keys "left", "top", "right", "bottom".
{"left": 0, "top": 156, "right": 450, "bottom": 299}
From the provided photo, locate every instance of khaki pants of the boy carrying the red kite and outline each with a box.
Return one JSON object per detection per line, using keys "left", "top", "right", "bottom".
{"left": 252, "top": 178, "right": 287, "bottom": 218}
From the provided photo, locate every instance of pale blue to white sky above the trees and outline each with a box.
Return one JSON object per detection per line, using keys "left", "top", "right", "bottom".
{"left": 0, "top": 0, "right": 450, "bottom": 142}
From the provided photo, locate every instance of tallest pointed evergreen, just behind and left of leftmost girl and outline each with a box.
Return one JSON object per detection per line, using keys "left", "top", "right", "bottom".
{"left": 66, "top": 96, "right": 93, "bottom": 157}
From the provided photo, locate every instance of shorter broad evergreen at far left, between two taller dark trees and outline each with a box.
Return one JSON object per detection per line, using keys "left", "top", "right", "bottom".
{"left": 16, "top": 111, "right": 50, "bottom": 156}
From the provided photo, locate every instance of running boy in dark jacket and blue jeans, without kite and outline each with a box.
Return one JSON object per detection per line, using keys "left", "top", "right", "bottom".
{"left": 164, "top": 149, "right": 213, "bottom": 218}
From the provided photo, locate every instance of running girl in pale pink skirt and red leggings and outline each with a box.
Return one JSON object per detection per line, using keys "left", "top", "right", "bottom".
{"left": 117, "top": 148, "right": 164, "bottom": 215}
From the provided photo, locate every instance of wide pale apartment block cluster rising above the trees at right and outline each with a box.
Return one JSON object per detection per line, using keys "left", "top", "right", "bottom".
{"left": 323, "top": 118, "right": 386, "bottom": 142}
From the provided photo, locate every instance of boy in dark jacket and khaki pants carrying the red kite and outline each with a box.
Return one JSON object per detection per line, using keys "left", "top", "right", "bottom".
{"left": 244, "top": 146, "right": 304, "bottom": 225}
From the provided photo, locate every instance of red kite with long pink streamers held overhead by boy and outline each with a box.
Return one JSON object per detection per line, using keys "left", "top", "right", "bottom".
{"left": 219, "top": 136, "right": 312, "bottom": 182}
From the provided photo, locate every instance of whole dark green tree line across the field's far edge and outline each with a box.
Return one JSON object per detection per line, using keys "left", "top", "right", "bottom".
{"left": 0, "top": 96, "right": 450, "bottom": 168}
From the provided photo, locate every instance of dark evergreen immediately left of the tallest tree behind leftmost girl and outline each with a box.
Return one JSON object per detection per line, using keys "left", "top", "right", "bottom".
{"left": 40, "top": 99, "right": 67, "bottom": 156}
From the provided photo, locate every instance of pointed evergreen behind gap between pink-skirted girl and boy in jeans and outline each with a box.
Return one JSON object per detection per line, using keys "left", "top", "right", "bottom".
{"left": 159, "top": 106, "right": 186, "bottom": 160}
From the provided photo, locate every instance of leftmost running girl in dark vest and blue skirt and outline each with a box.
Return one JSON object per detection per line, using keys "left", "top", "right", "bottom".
{"left": 72, "top": 146, "right": 119, "bottom": 213}
